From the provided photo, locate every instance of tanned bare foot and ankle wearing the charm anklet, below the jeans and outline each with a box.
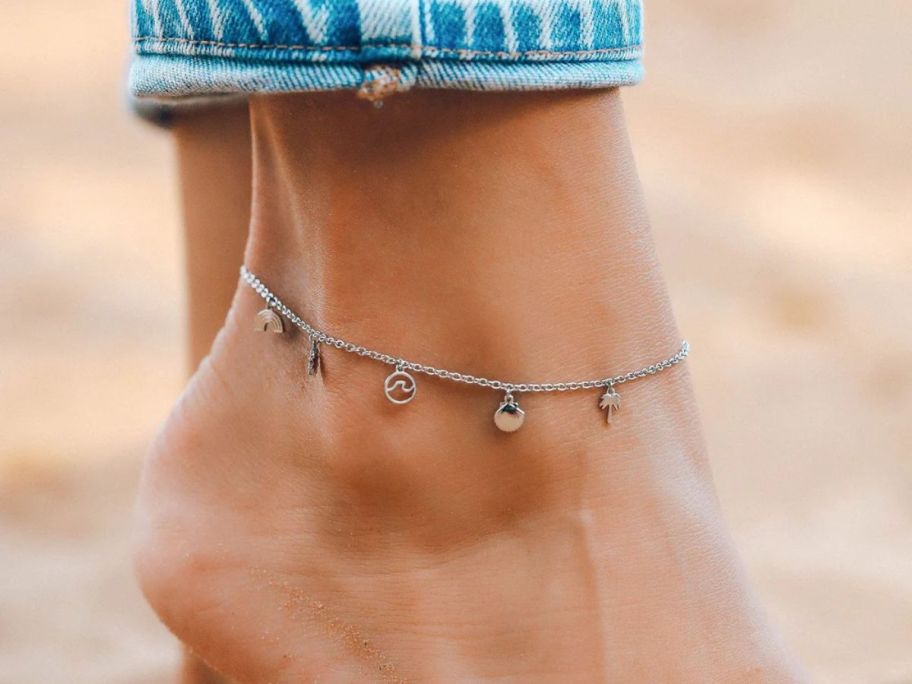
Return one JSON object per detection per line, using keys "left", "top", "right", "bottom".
{"left": 136, "top": 93, "right": 797, "bottom": 682}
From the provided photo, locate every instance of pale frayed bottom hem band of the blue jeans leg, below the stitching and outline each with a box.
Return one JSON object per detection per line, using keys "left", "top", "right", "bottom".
{"left": 130, "top": 55, "right": 643, "bottom": 99}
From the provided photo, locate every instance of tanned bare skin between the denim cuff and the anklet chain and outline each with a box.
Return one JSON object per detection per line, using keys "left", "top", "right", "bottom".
{"left": 247, "top": 92, "right": 680, "bottom": 398}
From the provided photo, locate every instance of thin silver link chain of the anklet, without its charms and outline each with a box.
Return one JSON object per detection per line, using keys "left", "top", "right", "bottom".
{"left": 241, "top": 266, "right": 690, "bottom": 394}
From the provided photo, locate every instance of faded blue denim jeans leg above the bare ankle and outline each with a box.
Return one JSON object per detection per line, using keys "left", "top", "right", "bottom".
{"left": 130, "top": 0, "right": 642, "bottom": 98}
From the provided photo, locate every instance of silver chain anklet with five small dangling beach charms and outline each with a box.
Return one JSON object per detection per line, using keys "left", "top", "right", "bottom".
{"left": 241, "top": 266, "right": 690, "bottom": 432}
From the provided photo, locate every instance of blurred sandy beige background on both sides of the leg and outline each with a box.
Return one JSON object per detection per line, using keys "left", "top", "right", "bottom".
{"left": 0, "top": 0, "right": 912, "bottom": 684}
